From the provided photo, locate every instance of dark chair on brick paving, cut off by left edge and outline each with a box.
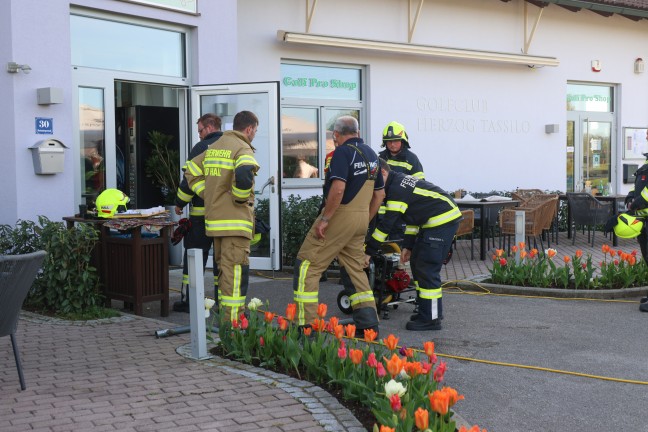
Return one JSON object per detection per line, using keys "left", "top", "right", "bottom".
{"left": 0, "top": 251, "right": 46, "bottom": 390}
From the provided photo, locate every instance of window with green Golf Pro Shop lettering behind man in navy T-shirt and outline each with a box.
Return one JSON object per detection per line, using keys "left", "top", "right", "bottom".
{"left": 281, "top": 63, "right": 363, "bottom": 187}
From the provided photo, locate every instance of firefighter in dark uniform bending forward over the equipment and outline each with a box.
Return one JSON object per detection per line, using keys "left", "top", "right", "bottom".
{"left": 366, "top": 159, "right": 461, "bottom": 330}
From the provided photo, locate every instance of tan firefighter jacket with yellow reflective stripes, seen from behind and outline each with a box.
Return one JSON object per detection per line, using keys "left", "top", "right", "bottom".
{"left": 185, "top": 131, "right": 259, "bottom": 239}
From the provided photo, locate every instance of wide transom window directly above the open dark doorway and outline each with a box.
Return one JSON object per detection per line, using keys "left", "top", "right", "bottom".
{"left": 70, "top": 15, "right": 186, "bottom": 77}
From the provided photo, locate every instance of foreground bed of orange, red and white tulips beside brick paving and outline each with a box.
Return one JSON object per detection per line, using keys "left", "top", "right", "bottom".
{"left": 207, "top": 299, "right": 481, "bottom": 432}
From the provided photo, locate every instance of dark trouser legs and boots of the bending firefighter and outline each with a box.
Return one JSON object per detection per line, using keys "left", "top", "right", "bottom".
{"left": 407, "top": 222, "right": 459, "bottom": 330}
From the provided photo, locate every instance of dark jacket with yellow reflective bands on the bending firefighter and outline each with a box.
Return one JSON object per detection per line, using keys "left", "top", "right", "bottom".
{"left": 366, "top": 171, "right": 461, "bottom": 255}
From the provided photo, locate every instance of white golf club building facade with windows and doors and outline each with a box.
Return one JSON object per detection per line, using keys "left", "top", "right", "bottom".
{"left": 0, "top": 0, "right": 648, "bottom": 268}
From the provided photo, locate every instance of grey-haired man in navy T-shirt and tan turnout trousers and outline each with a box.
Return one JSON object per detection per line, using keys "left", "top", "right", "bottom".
{"left": 293, "top": 116, "right": 385, "bottom": 337}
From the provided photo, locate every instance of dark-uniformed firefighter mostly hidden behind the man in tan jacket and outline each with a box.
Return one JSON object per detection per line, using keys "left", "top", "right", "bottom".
{"left": 173, "top": 113, "right": 223, "bottom": 312}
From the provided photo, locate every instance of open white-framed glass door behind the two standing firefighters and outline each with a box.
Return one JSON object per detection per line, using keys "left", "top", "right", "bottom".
{"left": 191, "top": 82, "right": 281, "bottom": 270}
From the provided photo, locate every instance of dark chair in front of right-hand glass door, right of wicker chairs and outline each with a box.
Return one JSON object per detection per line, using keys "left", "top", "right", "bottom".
{"left": 567, "top": 192, "right": 614, "bottom": 247}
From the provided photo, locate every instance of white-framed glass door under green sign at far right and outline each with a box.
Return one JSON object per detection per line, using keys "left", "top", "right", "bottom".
{"left": 567, "top": 113, "right": 613, "bottom": 193}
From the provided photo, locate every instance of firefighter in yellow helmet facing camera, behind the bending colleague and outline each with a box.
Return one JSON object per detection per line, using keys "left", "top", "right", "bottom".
{"left": 378, "top": 121, "right": 425, "bottom": 180}
